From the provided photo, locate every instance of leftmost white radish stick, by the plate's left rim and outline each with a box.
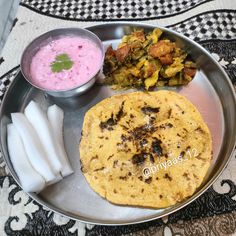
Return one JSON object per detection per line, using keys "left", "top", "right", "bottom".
{"left": 7, "top": 124, "right": 45, "bottom": 192}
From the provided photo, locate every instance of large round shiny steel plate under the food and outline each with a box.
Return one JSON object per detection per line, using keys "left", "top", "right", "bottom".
{"left": 0, "top": 22, "right": 236, "bottom": 225}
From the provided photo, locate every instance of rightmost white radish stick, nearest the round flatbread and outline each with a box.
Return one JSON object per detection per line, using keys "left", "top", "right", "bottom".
{"left": 47, "top": 105, "right": 73, "bottom": 177}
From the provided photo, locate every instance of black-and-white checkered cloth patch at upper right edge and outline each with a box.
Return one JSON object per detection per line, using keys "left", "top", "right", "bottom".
{"left": 169, "top": 10, "right": 236, "bottom": 41}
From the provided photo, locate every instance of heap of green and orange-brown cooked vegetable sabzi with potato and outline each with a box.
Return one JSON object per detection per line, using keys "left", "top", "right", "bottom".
{"left": 103, "top": 28, "right": 197, "bottom": 90}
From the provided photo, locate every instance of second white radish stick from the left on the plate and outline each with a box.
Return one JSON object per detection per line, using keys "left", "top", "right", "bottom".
{"left": 11, "top": 113, "right": 56, "bottom": 182}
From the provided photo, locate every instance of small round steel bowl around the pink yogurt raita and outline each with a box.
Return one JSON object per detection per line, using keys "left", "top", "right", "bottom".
{"left": 20, "top": 28, "right": 105, "bottom": 98}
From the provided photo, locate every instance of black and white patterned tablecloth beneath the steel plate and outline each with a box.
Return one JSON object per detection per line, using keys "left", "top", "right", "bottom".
{"left": 0, "top": 0, "right": 236, "bottom": 236}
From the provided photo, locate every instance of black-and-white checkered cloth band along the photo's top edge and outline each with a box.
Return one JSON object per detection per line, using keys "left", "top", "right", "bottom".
{"left": 21, "top": 0, "right": 212, "bottom": 21}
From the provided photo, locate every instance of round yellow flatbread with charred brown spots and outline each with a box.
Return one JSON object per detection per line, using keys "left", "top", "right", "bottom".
{"left": 80, "top": 90, "right": 212, "bottom": 208}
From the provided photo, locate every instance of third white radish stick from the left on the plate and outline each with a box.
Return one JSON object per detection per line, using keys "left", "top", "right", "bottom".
{"left": 25, "top": 101, "right": 62, "bottom": 175}
